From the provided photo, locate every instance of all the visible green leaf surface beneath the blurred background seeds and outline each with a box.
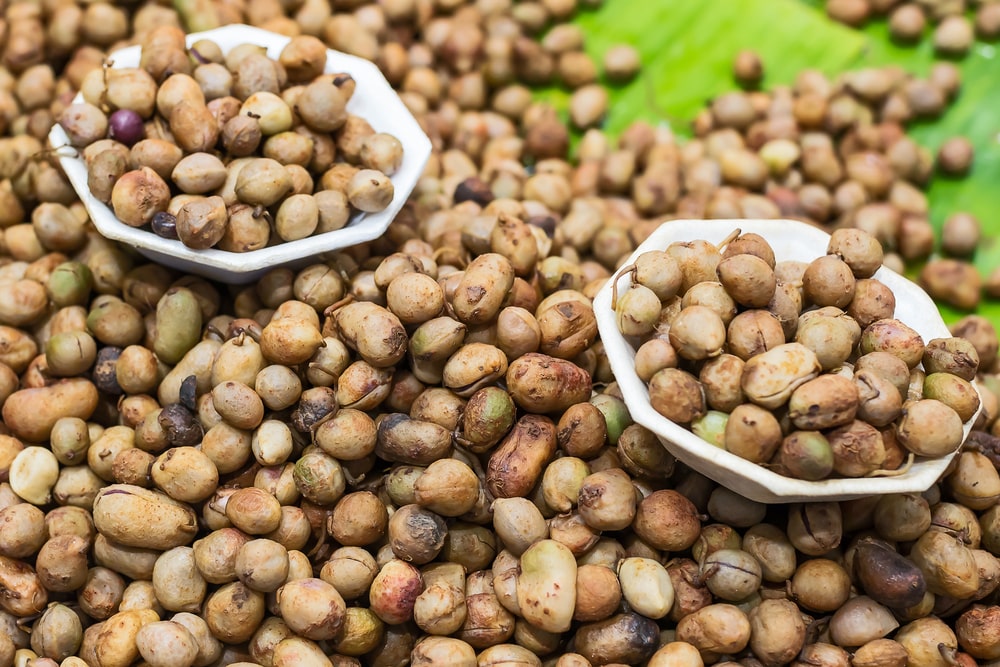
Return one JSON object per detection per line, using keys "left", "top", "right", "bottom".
{"left": 538, "top": 0, "right": 1000, "bottom": 324}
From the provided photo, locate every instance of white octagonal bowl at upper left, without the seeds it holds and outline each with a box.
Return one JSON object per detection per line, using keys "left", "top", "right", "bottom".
{"left": 49, "top": 25, "right": 431, "bottom": 284}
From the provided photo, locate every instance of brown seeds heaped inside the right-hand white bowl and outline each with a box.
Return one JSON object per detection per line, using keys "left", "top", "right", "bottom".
{"left": 613, "top": 229, "right": 980, "bottom": 481}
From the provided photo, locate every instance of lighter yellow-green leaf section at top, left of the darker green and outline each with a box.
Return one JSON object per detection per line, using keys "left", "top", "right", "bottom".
{"left": 538, "top": 0, "right": 865, "bottom": 135}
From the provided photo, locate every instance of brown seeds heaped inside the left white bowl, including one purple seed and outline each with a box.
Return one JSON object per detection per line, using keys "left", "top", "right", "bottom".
{"left": 59, "top": 27, "right": 404, "bottom": 252}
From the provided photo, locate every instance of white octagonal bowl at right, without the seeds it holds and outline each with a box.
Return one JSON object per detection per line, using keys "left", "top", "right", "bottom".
{"left": 594, "top": 220, "right": 979, "bottom": 503}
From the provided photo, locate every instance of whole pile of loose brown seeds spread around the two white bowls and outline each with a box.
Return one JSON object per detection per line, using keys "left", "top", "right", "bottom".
{"left": 0, "top": 0, "right": 1000, "bottom": 667}
